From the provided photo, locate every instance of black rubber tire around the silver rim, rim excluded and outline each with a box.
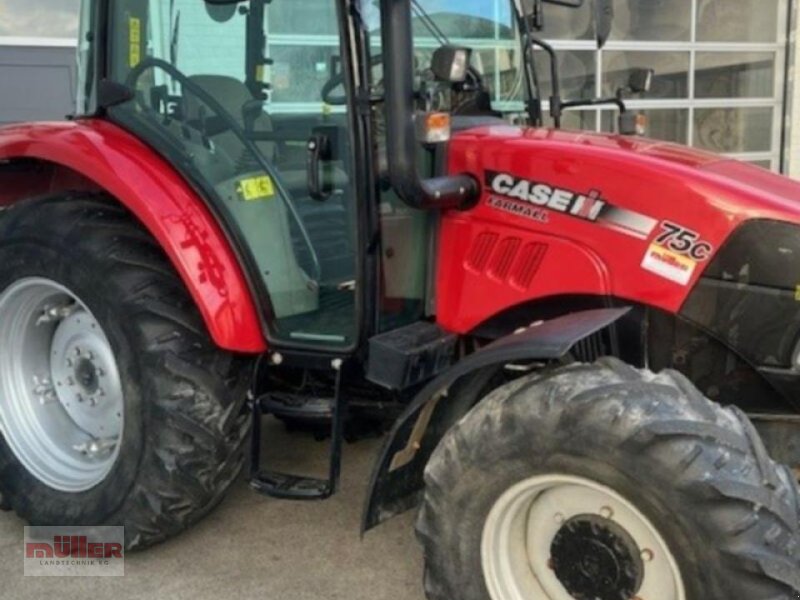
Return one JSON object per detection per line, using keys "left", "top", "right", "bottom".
{"left": 0, "top": 195, "right": 251, "bottom": 549}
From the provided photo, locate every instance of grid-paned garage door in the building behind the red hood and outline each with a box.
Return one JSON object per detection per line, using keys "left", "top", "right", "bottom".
{"left": 520, "top": 0, "right": 790, "bottom": 170}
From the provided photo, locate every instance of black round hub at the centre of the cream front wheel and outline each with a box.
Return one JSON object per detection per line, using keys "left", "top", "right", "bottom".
{"left": 550, "top": 515, "right": 644, "bottom": 600}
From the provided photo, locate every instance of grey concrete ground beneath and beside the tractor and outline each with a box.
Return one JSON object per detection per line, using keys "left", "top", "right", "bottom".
{"left": 0, "top": 424, "right": 424, "bottom": 600}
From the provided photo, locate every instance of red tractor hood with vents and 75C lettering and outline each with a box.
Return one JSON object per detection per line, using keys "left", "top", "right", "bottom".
{"left": 437, "top": 126, "right": 800, "bottom": 331}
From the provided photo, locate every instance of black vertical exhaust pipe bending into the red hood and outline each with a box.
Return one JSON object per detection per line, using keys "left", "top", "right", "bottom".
{"left": 381, "top": 0, "right": 480, "bottom": 210}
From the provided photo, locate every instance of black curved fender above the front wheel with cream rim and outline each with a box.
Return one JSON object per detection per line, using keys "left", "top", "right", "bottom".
{"left": 362, "top": 307, "right": 631, "bottom": 533}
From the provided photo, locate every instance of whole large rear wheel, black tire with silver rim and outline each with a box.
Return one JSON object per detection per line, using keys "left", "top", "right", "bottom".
{"left": 0, "top": 195, "right": 250, "bottom": 549}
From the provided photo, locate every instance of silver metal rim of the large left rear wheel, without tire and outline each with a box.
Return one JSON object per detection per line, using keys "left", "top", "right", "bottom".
{"left": 0, "top": 277, "right": 124, "bottom": 493}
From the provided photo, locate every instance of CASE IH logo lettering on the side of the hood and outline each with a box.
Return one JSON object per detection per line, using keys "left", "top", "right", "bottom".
{"left": 486, "top": 171, "right": 608, "bottom": 221}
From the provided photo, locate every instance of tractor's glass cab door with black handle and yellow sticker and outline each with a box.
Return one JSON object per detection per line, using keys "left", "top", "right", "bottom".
{"left": 111, "top": 0, "right": 359, "bottom": 350}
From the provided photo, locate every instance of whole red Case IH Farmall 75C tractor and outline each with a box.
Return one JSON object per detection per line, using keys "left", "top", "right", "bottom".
{"left": 0, "top": 0, "right": 800, "bottom": 600}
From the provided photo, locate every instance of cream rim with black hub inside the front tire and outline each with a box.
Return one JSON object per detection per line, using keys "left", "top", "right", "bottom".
{"left": 481, "top": 474, "right": 686, "bottom": 600}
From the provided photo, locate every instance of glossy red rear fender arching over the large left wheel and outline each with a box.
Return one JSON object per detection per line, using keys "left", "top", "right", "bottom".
{"left": 0, "top": 119, "right": 266, "bottom": 354}
